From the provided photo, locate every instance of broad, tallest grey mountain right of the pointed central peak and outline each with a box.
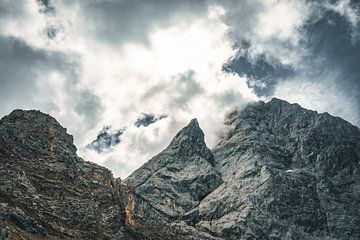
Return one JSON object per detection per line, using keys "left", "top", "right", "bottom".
{"left": 125, "top": 99, "right": 360, "bottom": 239}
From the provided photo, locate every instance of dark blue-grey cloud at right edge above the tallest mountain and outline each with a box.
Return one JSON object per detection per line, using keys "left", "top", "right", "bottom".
{"left": 304, "top": 8, "right": 360, "bottom": 95}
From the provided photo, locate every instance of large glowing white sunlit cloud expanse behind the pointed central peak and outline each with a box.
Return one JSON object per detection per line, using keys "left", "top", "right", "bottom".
{"left": 2, "top": 1, "right": 257, "bottom": 177}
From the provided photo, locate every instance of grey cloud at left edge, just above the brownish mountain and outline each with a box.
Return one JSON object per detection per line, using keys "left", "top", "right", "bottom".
{"left": 0, "top": 35, "right": 71, "bottom": 114}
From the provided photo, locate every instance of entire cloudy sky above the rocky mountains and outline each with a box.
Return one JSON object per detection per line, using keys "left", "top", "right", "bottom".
{"left": 0, "top": 0, "right": 360, "bottom": 178}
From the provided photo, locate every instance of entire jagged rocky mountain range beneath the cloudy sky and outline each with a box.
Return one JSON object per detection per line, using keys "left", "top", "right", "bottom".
{"left": 0, "top": 99, "right": 360, "bottom": 240}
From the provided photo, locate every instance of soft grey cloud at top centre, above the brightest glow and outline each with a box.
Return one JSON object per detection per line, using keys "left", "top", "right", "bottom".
{"left": 69, "top": 0, "right": 208, "bottom": 45}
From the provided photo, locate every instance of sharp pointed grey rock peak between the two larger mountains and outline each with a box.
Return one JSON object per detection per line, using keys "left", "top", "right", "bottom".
{"left": 125, "top": 119, "right": 221, "bottom": 227}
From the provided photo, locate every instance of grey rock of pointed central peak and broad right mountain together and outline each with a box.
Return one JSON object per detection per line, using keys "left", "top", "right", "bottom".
{"left": 126, "top": 99, "right": 360, "bottom": 240}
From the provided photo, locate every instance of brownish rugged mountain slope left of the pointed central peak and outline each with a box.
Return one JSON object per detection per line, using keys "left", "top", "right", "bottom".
{"left": 0, "top": 110, "right": 178, "bottom": 240}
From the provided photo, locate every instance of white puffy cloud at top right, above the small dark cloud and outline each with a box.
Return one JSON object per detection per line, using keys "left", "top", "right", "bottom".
{"left": 225, "top": 0, "right": 316, "bottom": 65}
